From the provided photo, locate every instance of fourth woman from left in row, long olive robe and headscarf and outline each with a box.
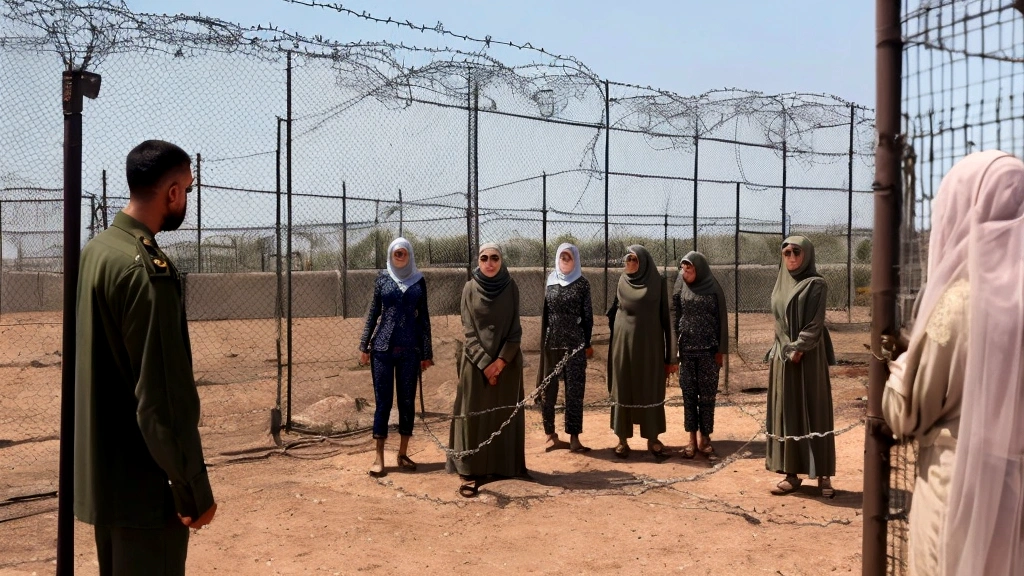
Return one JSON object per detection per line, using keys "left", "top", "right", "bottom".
{"left": 608, "top": 245, "right": 679, "bottom": 458}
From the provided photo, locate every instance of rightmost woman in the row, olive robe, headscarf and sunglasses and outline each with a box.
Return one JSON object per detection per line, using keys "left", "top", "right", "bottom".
{"left": 765, "top": 236, "right": 836, "bottom": 498}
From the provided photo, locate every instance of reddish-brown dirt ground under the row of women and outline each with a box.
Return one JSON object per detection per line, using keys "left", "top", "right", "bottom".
{"left": 0, "top": 310, "right": 867, "bottom": 576}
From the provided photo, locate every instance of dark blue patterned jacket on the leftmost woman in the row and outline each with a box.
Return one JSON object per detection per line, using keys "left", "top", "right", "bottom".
{"left": 359, "top": 271, "right": 434, "bottom": 360}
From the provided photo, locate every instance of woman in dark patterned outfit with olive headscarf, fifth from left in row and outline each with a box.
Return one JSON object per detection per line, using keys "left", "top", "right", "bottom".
{"left": 672, "top": 252, "right": 729, "bottom": 458}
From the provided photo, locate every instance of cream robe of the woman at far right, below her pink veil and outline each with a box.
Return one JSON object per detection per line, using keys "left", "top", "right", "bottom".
{"left": 882, "top": 280, "right": 970, "bottom": 575}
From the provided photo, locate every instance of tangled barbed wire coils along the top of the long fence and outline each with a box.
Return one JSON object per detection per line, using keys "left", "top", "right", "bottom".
{"left": 6, "top": 0, "right": 873, "bottom": 152}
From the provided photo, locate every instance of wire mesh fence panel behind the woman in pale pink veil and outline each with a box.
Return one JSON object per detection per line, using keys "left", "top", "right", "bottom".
{"left": 888, "top": 0, "right": 1024, "bottom": 574}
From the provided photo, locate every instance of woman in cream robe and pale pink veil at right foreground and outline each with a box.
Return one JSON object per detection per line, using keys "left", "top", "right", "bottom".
{"left": 883, "top": 151, "right": 1024, "bottom": 576}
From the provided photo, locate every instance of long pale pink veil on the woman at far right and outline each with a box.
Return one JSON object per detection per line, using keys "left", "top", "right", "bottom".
{"left": 911, "top": 151, "right": 1024, "bottom": 576}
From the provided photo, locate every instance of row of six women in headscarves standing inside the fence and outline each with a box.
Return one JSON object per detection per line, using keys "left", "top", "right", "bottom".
{"left": 359, "top": 237, "right": 836, "bottom": 496}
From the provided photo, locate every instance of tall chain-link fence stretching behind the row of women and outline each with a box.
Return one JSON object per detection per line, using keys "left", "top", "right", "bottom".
{"left": 0, "top": 0, "right": 873, "bottom": 545}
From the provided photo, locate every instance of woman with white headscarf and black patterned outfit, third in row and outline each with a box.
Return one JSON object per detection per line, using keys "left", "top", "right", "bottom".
{"left": 537, "top": 243, "right": 594, "bottom": 452}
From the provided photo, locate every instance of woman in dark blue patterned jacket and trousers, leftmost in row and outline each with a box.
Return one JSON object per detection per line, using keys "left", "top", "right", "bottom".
{"left": 359, "top": 238, "right": 433, "bottom": 476}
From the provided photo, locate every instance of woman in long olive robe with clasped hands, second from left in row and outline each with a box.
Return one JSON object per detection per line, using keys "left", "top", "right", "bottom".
{"left": 447, "top": 243, "right": 526, "bottom": 497}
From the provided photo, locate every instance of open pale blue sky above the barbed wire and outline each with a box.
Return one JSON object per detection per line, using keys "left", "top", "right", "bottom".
{"left": 128, "top": 0, "right": 874, "bottom": 108}
